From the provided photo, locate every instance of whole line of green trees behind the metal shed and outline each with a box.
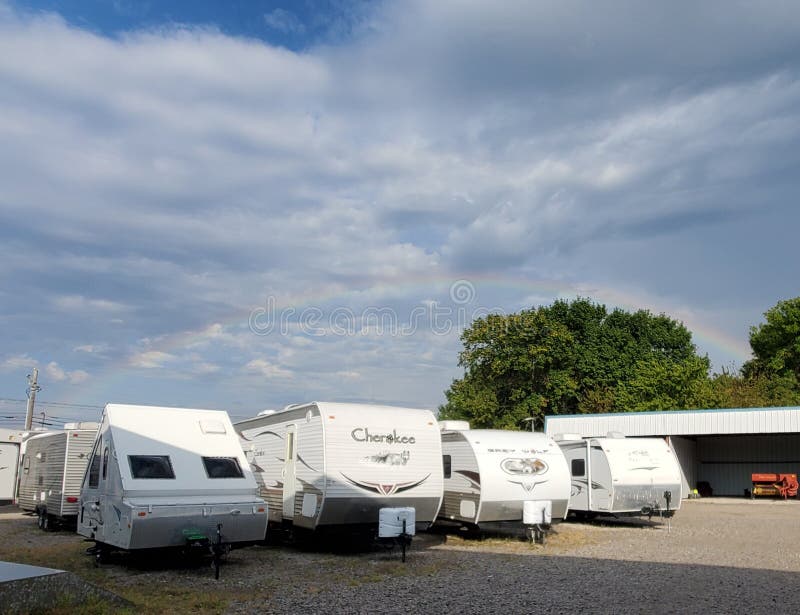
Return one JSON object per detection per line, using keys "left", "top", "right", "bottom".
{"left": 439, "top": 297, "right": 800, "bottom": 429}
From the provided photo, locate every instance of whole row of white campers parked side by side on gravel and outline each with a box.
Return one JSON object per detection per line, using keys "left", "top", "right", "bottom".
{"left": 0, "top": 402, "right": 680, "bottom": 556}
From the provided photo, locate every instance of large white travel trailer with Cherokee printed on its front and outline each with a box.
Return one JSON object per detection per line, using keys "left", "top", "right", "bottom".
{"left": 235, "top": 402, "right": 442, "bottom": 531}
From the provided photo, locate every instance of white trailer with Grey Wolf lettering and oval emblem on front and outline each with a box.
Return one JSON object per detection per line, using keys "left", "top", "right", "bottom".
{"left": 439, "top": 421, "right": 570, "bottom": 527}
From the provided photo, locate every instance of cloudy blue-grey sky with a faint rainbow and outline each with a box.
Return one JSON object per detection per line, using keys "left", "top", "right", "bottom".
{"left": 0, "top": 0, "right": 800, "bottom": 426}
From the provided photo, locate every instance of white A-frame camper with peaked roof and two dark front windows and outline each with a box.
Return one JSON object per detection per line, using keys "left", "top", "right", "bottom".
{"left": 78, "top": 404, "right": 267, "bottom": 550}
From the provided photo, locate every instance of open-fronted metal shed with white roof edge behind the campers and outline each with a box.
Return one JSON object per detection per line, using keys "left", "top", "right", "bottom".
{"left": 544, "top": 407, "right": 800, "bottom": 497}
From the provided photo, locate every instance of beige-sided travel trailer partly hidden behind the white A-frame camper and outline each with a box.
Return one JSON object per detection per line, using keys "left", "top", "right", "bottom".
{"left": 17, "top": 423, "right": 98, "bottom": 530}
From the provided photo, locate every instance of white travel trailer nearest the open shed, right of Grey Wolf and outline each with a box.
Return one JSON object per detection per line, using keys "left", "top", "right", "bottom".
{"left": 555, "top": 433, "right": 681, "bottom": 517}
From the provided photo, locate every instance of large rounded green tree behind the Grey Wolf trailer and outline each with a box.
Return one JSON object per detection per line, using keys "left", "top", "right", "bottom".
{"left": 440, "top": 298, "right": 709, "bottom": 428}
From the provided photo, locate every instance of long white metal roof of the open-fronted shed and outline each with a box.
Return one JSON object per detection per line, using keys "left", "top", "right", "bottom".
{"left": 544, "top": 406, "right": 800, "bottom": 437}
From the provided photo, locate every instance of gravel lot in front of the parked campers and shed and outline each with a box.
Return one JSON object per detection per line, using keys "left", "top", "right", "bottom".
{"left": 0, "top": 499, "right": 800, "bottom": 613}
